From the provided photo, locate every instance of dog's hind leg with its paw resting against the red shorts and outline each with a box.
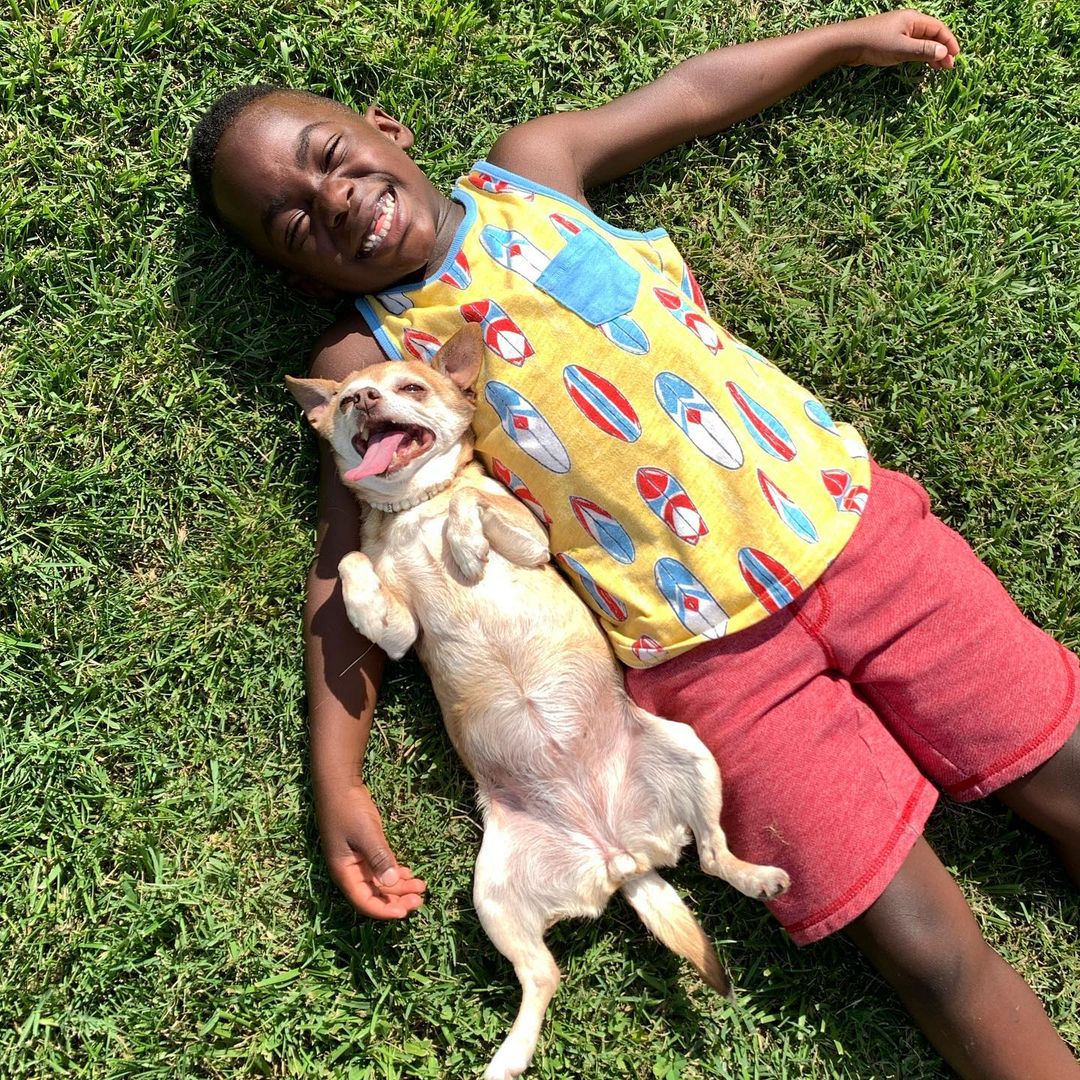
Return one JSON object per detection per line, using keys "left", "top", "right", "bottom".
{"left": 638, "top": 710, "right": 791, "bottom": 900}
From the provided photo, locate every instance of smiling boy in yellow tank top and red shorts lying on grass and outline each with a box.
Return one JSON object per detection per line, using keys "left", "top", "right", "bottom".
{"left": 192, "top": 11, "right": 1080, "bottom": 1078}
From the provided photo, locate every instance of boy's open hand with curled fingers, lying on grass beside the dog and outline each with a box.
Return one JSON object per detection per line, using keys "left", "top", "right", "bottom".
{"left": 319, "top": 784, "right": 426, "bottom": 919}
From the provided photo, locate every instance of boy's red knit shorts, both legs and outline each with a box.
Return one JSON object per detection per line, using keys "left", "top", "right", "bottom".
{"left": 626, "top": 465, "right": 1080, "bottom": 944}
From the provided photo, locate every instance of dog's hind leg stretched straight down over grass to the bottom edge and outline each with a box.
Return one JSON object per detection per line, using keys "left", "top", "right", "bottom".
{"left": 473, "top": 820, "right": 559, "bottom": 1080}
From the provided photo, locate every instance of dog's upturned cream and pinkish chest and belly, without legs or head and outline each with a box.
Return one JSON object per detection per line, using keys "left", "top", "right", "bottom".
{"left": 377, "top": 523, "right": 660, "bottom": 860}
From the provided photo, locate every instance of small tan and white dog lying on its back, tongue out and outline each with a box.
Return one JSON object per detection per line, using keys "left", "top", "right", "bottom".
{"left": 287, "top": 325, "right": 788, "bottom": 1080}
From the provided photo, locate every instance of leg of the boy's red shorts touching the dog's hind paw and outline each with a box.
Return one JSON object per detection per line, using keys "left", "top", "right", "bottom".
{"left": 626, "top": 613, "right": 936, "bottom": 944}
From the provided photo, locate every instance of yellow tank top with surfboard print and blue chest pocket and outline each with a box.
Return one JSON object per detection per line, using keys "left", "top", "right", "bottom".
{"left": 356, "top": 162, "right": 869, "bottom": 667}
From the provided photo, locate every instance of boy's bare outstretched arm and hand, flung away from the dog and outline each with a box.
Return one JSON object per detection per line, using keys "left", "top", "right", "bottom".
{"left": 489, "top": 11, "right": 960, "bottom": 200}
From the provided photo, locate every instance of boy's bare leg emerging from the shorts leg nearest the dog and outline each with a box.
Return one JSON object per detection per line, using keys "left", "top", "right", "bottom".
{"left": 847, "top": 839, "right": 1080, "bottom": 1080}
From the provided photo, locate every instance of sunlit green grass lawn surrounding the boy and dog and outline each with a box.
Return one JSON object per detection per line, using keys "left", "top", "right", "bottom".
{"left": 0, "top": 0, "right": 1080, "bottom": 1080}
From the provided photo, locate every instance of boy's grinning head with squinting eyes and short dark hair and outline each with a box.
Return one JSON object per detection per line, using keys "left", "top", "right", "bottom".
{"left": 213, "top": 94, "right": 447, "bottom": 294}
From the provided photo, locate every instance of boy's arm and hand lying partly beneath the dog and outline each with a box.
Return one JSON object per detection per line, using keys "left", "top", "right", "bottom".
{"left": 303, "top": 316, "right": 424, "bottom": 919}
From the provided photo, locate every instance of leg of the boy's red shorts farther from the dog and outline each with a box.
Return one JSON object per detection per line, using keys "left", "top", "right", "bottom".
{"left": 822, "top": 470, "right": 1080, "bottom": 801}
